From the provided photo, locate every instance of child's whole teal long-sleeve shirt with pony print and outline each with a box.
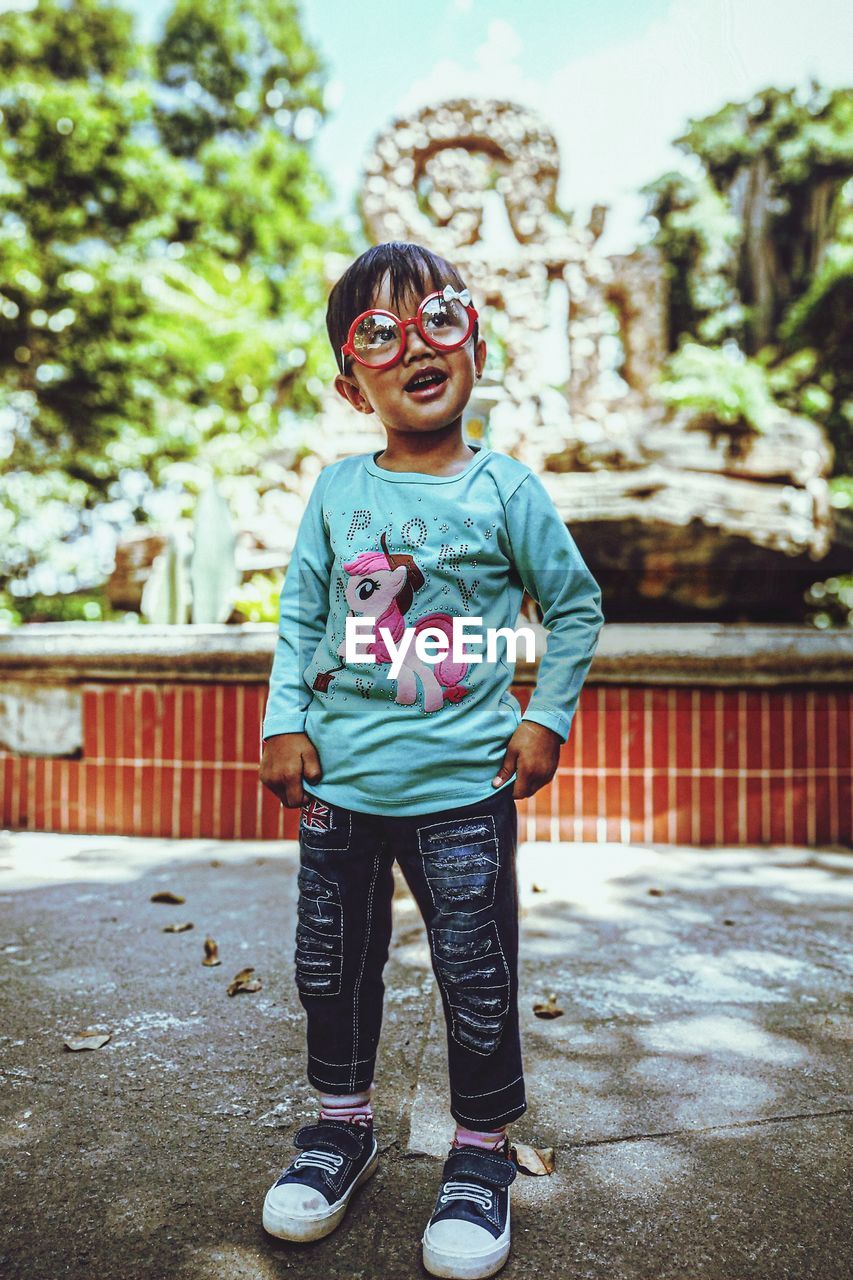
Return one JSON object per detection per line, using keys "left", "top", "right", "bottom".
{"left": 261, "top": 447, "right": 605, "bottom": 817}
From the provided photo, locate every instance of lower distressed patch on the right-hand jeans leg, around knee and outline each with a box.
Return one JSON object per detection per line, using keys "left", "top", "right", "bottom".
{"left": 429, "top": 920, "right": 510, "bottom": 1055}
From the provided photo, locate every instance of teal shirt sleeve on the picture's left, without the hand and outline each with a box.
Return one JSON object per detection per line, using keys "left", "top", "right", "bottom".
{"left": 261, "top": 472, "right": 334, "bottom": 740}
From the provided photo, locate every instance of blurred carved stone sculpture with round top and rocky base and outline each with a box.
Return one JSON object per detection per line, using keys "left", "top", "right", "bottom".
{"left": 307, "top": 99, "right": 839, "bottom": 617}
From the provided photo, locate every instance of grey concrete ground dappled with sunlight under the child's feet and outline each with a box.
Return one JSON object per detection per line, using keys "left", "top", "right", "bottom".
{"left": 0, "top": 832, "right": 853, "bottom": 1280}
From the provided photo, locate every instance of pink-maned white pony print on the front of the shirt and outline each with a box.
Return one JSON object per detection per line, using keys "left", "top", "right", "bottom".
{"left": 314, "top": 534, "right": 470, "bottom": 712}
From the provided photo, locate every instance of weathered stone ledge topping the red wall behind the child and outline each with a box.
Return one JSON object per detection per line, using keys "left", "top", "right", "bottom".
{"left": 0, "top": 618, "right": 853, "bottom": 685}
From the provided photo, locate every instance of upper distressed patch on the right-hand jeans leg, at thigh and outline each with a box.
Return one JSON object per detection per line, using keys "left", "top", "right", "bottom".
{"left": 418, "top": 814, "right": 498, "bottom": 915}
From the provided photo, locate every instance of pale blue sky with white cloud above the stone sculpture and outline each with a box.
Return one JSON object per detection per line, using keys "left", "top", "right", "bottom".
{"left": 6, "top": 0, "right": 853, "bottom": 252}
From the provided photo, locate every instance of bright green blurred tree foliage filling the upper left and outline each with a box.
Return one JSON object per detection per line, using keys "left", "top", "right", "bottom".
{"left": 0, "top": 0, "right": 348, "bottom": 591}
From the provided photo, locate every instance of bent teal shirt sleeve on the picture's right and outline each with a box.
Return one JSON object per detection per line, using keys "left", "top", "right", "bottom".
{"left": 506, "top": 472, "right": 605, "bottom": 742}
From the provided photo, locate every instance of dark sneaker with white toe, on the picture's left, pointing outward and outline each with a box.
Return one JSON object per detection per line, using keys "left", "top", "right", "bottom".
{"left": 263, "top": 1120, "right": 379, "bottom": 1240}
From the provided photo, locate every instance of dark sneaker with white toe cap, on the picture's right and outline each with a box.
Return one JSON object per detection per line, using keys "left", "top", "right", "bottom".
{"left": 423, "top": 1138, "right": 516, "bottom": 1280}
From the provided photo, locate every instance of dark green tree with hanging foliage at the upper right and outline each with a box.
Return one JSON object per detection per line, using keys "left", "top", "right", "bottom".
{"left": 644, "top": 83, "right": 853, "bottom": 472}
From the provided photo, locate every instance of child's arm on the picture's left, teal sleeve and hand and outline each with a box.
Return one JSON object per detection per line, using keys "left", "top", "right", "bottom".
{"left": 260, "top": 471, "right": 334, "bottom": 808}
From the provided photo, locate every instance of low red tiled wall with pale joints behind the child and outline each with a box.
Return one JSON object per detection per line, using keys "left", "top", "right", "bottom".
{"left": 0, "top": 682, "right": 853, "bottom": 845}
